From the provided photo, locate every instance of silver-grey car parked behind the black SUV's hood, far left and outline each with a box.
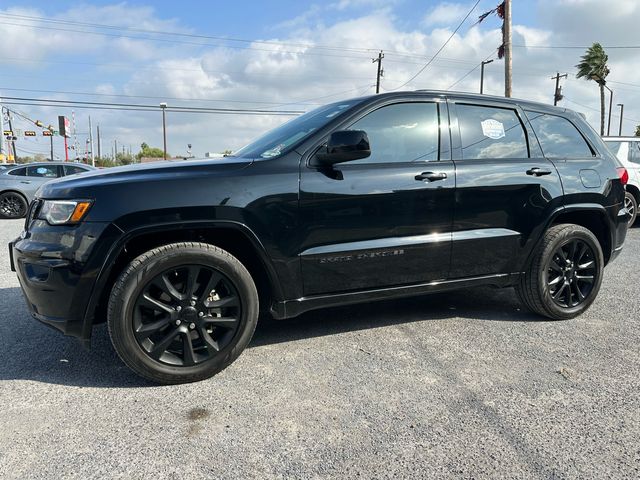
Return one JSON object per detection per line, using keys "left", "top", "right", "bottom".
{"left": 0, "top": 162, "right": 94, "bottom": 218}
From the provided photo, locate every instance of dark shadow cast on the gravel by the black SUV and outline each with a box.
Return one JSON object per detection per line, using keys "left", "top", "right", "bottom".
{"left": 0, "top": 288, "right": 540, "bottom": 388}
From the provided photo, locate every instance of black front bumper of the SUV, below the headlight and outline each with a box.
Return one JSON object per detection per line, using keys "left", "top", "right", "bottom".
{"left": 9, "top": 220, "right": 117, "bottom": 340}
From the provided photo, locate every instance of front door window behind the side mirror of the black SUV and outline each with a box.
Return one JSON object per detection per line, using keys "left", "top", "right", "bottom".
{"left": 349, "top": 103, "right": 439, "bottom": 163}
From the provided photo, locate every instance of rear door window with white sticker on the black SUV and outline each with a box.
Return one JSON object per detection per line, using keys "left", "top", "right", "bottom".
{"left": 456, "top": 104, "right": 529, "bottom": 159}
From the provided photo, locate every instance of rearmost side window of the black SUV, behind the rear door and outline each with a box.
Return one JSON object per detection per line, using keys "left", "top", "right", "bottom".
{"left": 527, "top": 111, "right": 593, "bottom": 158}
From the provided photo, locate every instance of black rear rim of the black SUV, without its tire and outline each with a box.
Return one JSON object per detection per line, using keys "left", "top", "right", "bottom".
{"left": 547, "top": 238, "right": 598, "bottom": 308}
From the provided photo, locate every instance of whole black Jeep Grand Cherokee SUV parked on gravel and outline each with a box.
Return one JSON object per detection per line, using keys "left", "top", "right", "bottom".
{"left": 10, "top": 91, "right": 628, "bottom": 383}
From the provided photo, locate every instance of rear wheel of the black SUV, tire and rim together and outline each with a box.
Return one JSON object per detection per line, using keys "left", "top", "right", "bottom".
{"left": 516, "top": 224, "right": 604, "bottom": 320}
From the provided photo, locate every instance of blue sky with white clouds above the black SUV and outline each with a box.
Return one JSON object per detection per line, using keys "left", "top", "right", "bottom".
{"left": 0, "top": 0, "right": 640, "bottom": 157}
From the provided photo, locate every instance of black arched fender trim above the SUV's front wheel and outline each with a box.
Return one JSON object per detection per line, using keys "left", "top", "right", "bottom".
{"left": 82, "top": 220, "right": 283, "bottom": 342}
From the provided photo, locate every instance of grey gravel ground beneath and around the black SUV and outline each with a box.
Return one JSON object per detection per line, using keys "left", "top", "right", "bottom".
{"left": 0, "top": 221, "right": 640, "bottom": 479}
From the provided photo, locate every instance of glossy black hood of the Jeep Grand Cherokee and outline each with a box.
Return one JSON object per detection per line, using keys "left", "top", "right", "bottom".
{"left": 36, "top": 157, "right": 253, "bottom": 199}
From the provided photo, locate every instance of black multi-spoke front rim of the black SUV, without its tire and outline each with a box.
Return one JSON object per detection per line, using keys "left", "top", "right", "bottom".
{"left": 133, "top": 265, "right": 242, "bottom": 366}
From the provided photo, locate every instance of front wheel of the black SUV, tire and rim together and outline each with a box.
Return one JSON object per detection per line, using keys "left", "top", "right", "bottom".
{"left": 107, "top": 242, "right": 259, "bottom": 384}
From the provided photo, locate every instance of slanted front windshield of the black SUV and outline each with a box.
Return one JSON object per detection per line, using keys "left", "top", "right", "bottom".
{"left": 233, "top": 99, "right": 362, "bottom": 158}
